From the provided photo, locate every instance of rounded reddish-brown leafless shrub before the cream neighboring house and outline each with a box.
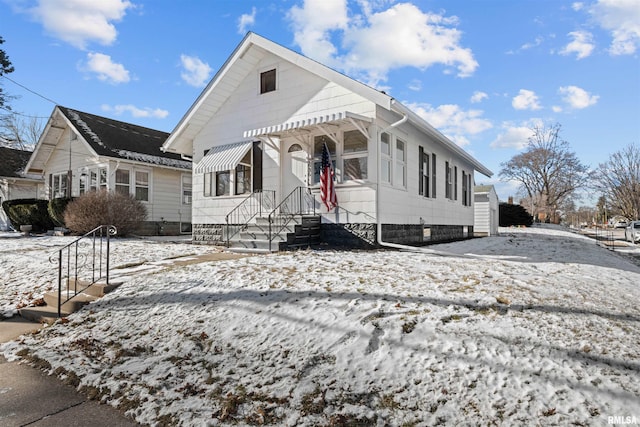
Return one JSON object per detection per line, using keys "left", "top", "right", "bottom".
{"left": 64, "top": 190, "right": 147, "bottom": 236}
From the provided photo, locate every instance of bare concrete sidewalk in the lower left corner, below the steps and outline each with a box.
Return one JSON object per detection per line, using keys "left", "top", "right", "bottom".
{"left": 0, "top": 316, "right": 139, "bottom": 427}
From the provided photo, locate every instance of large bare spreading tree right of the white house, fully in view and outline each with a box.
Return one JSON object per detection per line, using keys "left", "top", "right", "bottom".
{"left": 500, "top": 123, "right": 588, "bottom": 222}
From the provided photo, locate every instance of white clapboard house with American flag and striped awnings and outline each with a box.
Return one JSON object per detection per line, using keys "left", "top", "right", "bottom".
{"left": 163, "top": 33, "right": 492, "bottom": 251}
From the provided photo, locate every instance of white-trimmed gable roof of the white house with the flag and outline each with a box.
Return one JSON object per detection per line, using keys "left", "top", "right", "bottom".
{"left": 162, "top": 32, "right": 493, "bottom": 177}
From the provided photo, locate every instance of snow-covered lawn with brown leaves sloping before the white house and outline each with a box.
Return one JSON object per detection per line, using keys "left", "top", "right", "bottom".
{"left": 0, "top": 228, "right": 640, "bottom": 426}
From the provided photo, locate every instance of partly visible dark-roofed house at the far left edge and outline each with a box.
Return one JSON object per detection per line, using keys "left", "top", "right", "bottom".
{"left": 0, "top": 147, "right": 44, "bottom": 230}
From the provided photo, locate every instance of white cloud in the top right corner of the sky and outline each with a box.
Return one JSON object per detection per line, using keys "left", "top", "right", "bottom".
{"left": 589, "top": 0, "right": 640, "bottom": 55}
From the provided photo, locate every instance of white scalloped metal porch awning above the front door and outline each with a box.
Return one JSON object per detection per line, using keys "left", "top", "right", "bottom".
{"left": 244, "top": 111, "right": 373, "bottom": 138}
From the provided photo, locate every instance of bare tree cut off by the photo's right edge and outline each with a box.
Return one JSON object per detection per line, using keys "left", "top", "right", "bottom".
{"left": 591, "top": 144, "right": 640, "bottom": 220}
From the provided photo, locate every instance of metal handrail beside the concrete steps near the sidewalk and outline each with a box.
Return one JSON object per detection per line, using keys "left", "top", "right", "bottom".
{"left": 49, "top": 225, "right": 117, "bottom": 317}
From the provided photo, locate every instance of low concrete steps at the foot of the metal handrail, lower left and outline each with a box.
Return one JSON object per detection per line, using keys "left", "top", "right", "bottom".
{"left": 18, "top": 280, "right": 122, "bottom": 324}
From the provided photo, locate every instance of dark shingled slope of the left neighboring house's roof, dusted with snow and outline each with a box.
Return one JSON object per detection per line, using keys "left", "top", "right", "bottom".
{"left": 59, "top": 107, "right": 191, "bottom": 169}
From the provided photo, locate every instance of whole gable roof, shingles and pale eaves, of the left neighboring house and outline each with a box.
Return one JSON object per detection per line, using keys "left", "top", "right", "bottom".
{"left": 27, "top": 106, "right": 191, "bottom": 174}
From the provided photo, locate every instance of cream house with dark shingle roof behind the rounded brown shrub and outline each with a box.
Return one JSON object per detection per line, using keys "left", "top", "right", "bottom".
{"left": 26, "top": 106, "right": 191, "bottom": 234}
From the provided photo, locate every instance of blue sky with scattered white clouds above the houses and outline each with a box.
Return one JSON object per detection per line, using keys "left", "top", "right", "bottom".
{"left": 0, "top": 0, "right": 640, "bottom": 200}
